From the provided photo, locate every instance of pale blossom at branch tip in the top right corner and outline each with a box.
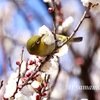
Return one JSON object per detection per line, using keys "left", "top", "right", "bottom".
{"left": 81, "top": 0, "right": 100, "bottom": 13}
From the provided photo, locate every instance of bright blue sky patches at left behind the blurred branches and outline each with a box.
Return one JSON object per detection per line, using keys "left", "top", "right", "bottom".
{"left": 0, "top": 0, "right": 52, "bottom": 74}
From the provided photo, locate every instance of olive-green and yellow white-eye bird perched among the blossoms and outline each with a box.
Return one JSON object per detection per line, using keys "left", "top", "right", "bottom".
{"left": 26, "top": 34, "right": 82, "bottom": 57}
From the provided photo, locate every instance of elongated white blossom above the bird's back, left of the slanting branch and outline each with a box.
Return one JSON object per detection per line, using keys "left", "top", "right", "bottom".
{"left": 62, "top": 16, "right": 74, "bottom": 31}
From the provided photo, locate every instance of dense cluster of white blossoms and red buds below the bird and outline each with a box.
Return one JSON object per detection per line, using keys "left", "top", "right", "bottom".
{"left": 4, "top": 56, "right": 49, "bottom": 100}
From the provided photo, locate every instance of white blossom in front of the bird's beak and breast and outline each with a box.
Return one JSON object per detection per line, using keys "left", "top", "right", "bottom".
{"left": 38, "top": 25, "right": 55, "bottom": 45}
